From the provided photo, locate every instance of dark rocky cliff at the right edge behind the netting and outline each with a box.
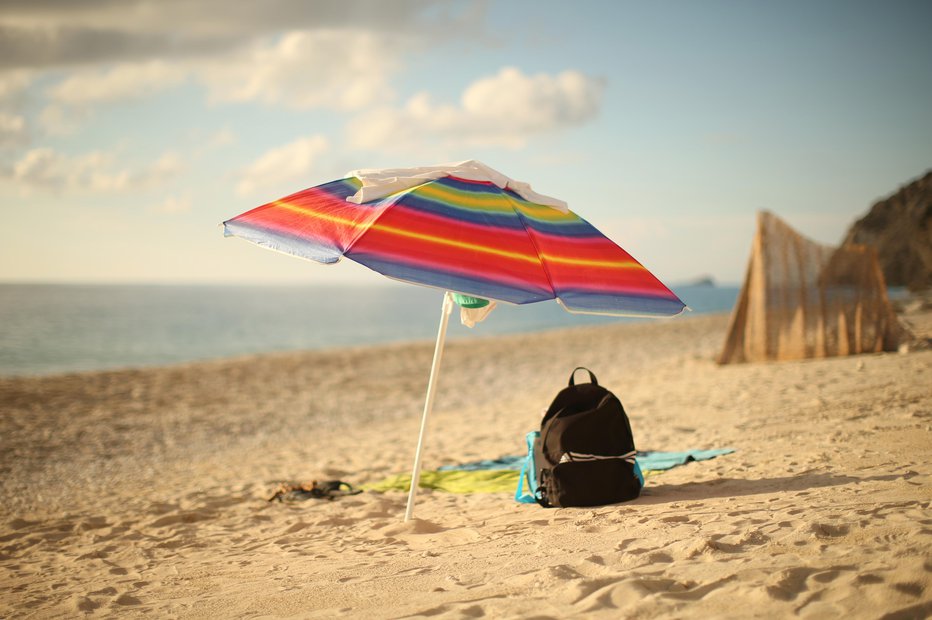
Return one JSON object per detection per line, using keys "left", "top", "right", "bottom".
{"left": 844, "top": 171, "right": 932, "bottom": 290}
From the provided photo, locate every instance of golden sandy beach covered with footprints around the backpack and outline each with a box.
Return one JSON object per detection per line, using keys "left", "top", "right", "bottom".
{"left": 0, "top": 312, "right": 932, "bottom": 618}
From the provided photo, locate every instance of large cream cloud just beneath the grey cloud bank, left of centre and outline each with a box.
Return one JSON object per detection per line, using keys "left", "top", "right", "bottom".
{"left": 198, "top": 30, "right": 404, "bottom": 110}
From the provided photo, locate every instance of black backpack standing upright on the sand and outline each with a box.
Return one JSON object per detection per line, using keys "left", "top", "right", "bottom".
{"left": 534, "top": 367, "right": 641, "bottom": 506}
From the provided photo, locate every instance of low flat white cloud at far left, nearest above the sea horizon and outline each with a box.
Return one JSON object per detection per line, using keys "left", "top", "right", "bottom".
{"left": 10, "top": 147, "right": 182, "bottom": 193}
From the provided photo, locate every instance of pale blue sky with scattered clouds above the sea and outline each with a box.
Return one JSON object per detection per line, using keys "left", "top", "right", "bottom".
{"left": 0, "top": 0, "right": 932, "bottom": 284}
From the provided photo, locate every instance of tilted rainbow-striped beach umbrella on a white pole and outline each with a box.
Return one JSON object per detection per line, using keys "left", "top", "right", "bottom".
{"left": 223, "top": 161, "right": 685, "bottom": 520}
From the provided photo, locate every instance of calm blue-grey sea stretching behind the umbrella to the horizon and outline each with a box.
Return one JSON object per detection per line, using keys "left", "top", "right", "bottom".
{"left": 0, "top": 283, "right": 739, "bottom": 376}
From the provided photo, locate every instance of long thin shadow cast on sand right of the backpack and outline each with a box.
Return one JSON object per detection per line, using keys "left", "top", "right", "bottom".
{"left": 637, "top": 473, "right": 902, "bottom": 505}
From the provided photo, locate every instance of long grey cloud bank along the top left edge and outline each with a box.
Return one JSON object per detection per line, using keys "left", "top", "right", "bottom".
{"left": 0, "top": 0, "right": 458, "bottom": 69}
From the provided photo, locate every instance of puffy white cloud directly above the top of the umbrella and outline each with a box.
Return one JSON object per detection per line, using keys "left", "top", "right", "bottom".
{"left": 348, "top": 67, "right": 604, "bottom": 150}
